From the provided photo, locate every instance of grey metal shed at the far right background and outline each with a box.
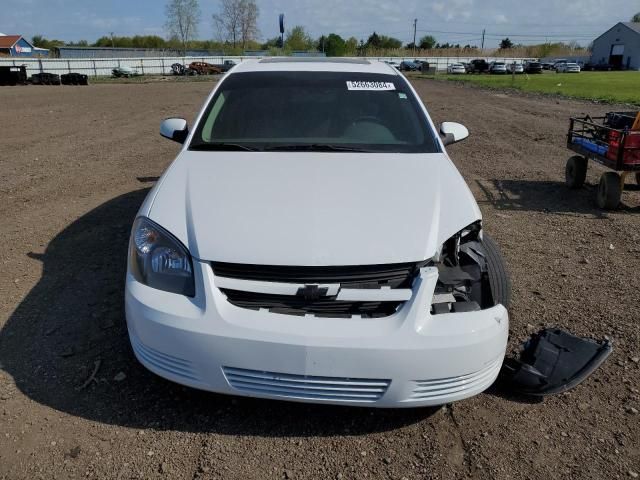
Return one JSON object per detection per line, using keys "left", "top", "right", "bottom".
{"left": 591, "top": 22, "right": 640, "bottom": 70}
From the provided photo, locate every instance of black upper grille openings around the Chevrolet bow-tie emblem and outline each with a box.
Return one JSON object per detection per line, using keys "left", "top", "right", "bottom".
{"left": 211, "top": 262, "right": 427, "bottom": 318}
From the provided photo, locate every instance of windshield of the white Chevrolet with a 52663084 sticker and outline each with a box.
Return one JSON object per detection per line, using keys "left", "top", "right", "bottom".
{"left": 189, "top": 72, "right": 440, "bottom": 153}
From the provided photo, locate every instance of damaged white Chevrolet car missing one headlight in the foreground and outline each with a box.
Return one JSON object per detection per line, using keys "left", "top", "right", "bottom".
{"left": 125, "top": 58, "right": 510, "bottom": 407}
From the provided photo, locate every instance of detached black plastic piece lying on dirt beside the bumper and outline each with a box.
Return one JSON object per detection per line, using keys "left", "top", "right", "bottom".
{"left": 500, "top": 328, "right": 613, "bottom": 396}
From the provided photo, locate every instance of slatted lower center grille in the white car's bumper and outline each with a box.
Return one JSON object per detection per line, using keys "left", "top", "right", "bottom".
{"left": 222, "top": 367, "right": 391, "bottom": 402}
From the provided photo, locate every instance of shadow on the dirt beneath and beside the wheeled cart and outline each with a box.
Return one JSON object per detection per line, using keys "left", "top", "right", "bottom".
{"left": 475, "top": 179, "right": 640, "bottom": 218}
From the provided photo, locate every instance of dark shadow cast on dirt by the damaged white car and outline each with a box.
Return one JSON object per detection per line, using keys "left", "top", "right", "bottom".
{"left": 0, "top": 188, "right": 438, "bottom": 436}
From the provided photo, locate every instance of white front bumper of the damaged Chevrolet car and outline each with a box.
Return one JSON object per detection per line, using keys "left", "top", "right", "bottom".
{"left": 125, "top": 261, "right": 508, "bottom": 407}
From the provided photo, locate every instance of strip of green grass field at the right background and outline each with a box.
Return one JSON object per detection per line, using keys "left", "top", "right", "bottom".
{"left": 437, "top": 72, "right": 640, "bottom": 105}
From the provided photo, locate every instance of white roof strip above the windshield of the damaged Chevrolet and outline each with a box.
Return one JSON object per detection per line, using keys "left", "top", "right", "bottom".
{"left": 230, "top": 57, "right": 400, "bottom": 75}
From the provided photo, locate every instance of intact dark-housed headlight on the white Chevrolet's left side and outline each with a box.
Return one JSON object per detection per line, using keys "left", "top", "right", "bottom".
{"left": 129, "top": 217, "right": 195, "bottom": 297}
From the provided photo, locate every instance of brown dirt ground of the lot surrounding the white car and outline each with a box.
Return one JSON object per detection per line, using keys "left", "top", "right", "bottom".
{"left": 0, "top": 80, "right": 640, "bottom": 480}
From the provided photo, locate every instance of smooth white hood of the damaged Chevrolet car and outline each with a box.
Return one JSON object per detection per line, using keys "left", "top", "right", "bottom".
{"left": 148, "top": 150, "right": 480, "bottom": 265}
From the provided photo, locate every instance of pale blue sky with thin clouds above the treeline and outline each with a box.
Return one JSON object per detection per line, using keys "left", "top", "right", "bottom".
{"left": 0, "top": 0, "right": 640, "bottom": 47}
